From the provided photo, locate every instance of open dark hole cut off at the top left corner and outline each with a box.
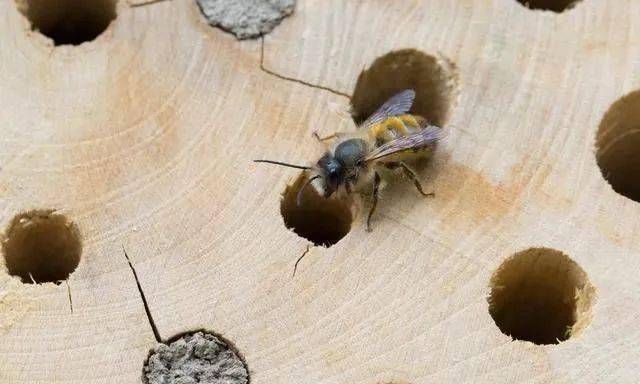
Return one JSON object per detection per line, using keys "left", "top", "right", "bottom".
{"left": 16, "top": 0, "right": 117, "bottom": 45}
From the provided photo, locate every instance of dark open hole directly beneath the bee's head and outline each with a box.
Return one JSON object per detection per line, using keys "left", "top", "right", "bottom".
{"left": 280, "top": 173, "right": 353, "bottom": 247}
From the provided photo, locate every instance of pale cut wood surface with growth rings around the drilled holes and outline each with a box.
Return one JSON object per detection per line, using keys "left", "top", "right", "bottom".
{"left": 0, "top": 0, "right": 640, "bottom": 384}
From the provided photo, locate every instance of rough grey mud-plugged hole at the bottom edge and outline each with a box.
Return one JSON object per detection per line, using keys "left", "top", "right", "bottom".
{"left": 142, "top": 331, "right": 249, "bottom": 384}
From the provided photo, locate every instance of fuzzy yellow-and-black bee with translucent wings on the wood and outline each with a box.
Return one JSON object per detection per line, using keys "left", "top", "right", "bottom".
{"left": 254, "top": 89, "right": 443, "bottom": 232}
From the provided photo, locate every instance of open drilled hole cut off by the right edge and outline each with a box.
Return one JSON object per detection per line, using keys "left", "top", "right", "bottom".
{"left": 596, "top": 91, "right": 640, "bottom": 202}
